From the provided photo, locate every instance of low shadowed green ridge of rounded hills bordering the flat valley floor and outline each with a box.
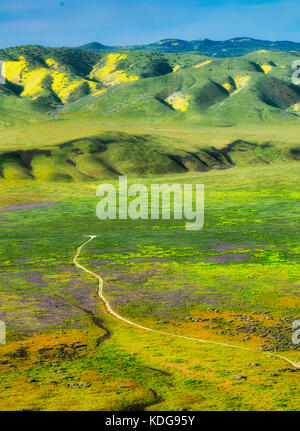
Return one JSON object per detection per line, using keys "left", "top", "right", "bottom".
{"left": 0, "top": 132, "right": 299, "bottom": 182}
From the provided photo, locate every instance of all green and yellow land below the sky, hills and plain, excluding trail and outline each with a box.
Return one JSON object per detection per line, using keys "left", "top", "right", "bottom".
{"left": 0, "top": 46, "right": 300, "bottom": 410}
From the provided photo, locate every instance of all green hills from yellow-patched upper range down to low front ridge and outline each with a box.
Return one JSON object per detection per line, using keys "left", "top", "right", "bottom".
{"left": 0, "top": 46, "right": 300, "bottom": 181}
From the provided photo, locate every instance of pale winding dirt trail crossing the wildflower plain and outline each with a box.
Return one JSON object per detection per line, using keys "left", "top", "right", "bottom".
{"left": 73, "top": 235, "right": 300, "bottom": 369}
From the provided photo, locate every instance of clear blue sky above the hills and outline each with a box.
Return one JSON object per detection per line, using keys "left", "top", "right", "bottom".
{"left": 0, "top": 0, "right": 300, "bottom": 47}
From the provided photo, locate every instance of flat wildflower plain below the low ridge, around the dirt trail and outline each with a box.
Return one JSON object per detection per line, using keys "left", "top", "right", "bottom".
{"left": 0, "top": 162, "right": 300, "bottom": 410}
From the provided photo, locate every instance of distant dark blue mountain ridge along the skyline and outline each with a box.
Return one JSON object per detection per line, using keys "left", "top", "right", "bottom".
{"left": 79, "top": 37, "right": 300, "bottom": 58}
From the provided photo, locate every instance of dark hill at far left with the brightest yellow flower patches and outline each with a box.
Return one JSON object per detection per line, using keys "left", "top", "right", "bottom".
{"left": 0, "top": 47, "right": 104, "bottom": 108}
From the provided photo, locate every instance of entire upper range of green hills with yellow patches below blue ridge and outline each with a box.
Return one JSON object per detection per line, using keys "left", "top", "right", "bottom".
{"left": 0, "top": 47, "right": 300, "bottom": 126}
